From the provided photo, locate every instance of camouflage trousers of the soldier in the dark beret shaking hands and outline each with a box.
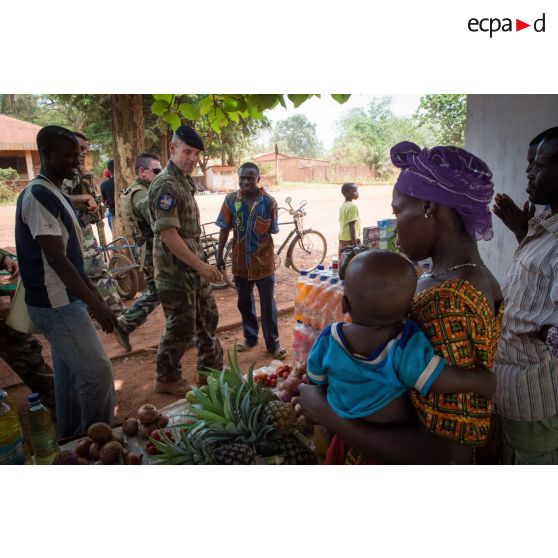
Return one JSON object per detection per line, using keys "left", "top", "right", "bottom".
{"left": 157, "top": 285, "right": 223, "bottom": 383}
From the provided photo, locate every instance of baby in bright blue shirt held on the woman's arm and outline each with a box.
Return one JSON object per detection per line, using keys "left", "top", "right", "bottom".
{"left": 306, "top": 250, "right": 496, "bottom": 422}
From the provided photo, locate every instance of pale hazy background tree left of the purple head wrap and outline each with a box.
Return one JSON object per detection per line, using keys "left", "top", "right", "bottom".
{"left": 331, "top": 97, "right": 432, "bottom": 179}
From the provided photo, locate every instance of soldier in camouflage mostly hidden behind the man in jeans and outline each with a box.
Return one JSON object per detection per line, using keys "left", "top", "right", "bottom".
{"left": 65, "top": 132, "right": 125, "bottom": 320}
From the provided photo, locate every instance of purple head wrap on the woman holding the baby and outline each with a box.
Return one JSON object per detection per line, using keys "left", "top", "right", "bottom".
{"left": 390, "top": 141, "right": 494, "bottom": 240}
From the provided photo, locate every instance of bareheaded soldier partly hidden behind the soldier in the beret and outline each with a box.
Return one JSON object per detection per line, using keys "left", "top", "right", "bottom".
{"left": 118, "top": 153, "right": 162, "bottom": 350}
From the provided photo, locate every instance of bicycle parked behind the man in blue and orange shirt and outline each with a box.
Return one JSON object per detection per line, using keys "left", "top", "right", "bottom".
{"left": 218, "top": 196, "right": 327, "bottom": 288}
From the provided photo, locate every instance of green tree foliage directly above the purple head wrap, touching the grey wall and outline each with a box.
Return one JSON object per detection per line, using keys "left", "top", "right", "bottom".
{"left": 414, "top": 94, "right": 467, "bottom": 147}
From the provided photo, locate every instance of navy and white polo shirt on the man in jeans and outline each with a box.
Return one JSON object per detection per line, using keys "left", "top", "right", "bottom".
{"left": 15, "top": 178, "right": 86, "bottom": 308}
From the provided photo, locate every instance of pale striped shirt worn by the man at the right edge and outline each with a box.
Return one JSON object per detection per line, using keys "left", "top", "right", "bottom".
{"left": 494, "top": 211, "right": 558, "bottom": 422}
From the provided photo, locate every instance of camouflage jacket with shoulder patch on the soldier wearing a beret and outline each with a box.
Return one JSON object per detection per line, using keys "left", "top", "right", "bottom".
{"left": 148, "top": 161, "right": 205, "bottom": 291}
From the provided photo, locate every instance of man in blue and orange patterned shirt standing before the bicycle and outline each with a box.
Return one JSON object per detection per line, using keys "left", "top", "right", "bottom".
{"left": 216, "top": 163, "right": 287, "bottom": 359}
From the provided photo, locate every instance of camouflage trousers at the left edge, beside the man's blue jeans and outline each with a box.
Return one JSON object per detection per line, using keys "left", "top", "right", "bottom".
{"left": 0, "top": 322, "right": 54, "bottom": 410}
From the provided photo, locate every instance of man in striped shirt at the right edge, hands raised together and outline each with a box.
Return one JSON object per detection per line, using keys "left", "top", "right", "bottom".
{"left": 494, "top": 128, "right": 558, "bottom": 464}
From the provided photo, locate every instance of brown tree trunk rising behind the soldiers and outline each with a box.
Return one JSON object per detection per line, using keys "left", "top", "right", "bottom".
{"left": 111, "top": 95, "right": 145, "bottom": 238}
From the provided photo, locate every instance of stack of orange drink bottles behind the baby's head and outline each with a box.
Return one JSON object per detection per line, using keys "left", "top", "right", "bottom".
{"left": 293, "top": 258, "right": 349, "bottom": 363}
